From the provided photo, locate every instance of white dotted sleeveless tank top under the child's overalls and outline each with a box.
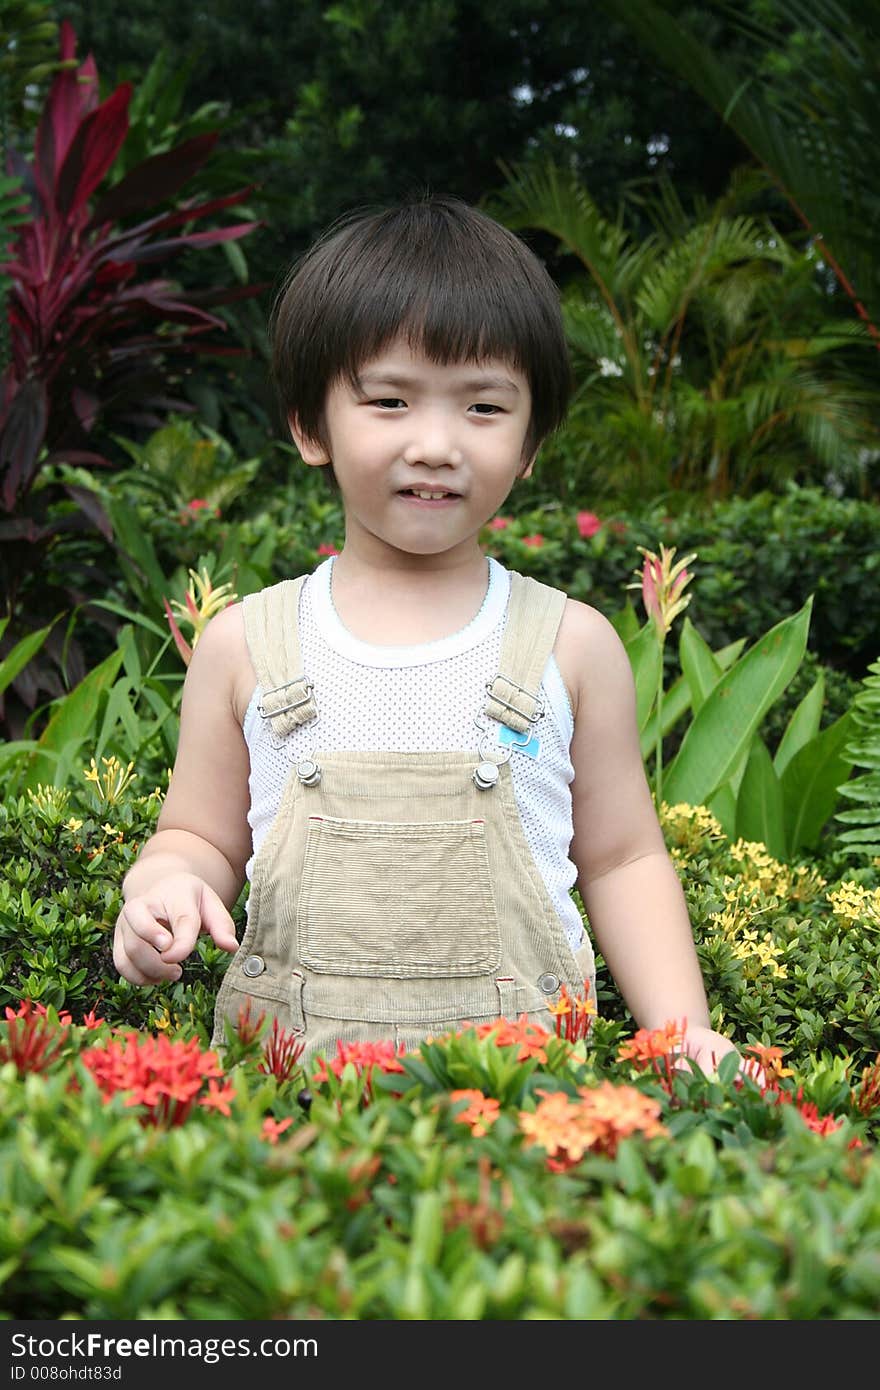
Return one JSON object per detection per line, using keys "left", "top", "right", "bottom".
{"left": 243, "top": 556, "right": 584, "bottom": 949}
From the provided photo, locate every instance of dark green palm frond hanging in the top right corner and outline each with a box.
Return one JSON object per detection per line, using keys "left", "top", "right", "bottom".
{"left": 613, "top": 0, "right": 880, "bottom": 350}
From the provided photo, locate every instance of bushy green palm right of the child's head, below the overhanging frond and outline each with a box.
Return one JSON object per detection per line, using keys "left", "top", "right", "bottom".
{"left": 489, "top": 164, "right": 870, "bottom": 499}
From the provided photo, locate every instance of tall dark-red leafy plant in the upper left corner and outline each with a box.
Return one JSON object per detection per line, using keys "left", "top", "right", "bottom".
{"left": 0, "top": 21, "right": 261, "bottom": 728}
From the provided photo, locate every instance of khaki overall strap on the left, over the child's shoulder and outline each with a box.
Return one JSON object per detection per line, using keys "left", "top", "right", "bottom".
{"left": 242, "top": 574, "right": 318, "bottom": 737}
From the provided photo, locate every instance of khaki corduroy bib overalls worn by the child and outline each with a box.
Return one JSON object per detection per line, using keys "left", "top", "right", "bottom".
{"left": 213, "top": 574, "right": 595, "bottom": 1059}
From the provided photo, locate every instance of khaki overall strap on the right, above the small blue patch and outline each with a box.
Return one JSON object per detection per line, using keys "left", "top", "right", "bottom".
{"left": 485, "top": 571, "right": 566, "bottom": 734}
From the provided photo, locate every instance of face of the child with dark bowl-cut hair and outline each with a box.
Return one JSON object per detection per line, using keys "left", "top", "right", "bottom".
{"left": 291, "top": 339, "right": 534, "bottom": 557}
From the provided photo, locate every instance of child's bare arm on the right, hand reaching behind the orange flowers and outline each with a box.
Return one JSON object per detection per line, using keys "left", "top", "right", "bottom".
{"left": 557, "top": 600, "right": 735, "bottom": 1070}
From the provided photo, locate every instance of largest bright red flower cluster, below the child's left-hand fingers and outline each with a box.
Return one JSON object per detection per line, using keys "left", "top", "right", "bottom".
{"left": 82, "top": 1033, "right": 235, "bottom": 1129}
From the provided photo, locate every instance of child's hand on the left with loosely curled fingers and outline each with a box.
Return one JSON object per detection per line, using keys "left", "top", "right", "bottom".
{"left": 113, "top": 873, "right": 238, "bottom": 984}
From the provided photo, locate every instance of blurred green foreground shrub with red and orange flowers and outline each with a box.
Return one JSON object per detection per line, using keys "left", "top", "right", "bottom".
{"left": 0, "top": 1009, "right": 880, "bottom": 1321}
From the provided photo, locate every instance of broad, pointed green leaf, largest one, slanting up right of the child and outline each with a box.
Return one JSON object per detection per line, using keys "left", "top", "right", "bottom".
{"left": 663, "top": 595, "right": 813, "bottom": 806}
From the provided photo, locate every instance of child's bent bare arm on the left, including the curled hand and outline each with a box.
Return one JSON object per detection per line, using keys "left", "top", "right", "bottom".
{"left": 114, "top": 605, "right": 252, "bottom": 984}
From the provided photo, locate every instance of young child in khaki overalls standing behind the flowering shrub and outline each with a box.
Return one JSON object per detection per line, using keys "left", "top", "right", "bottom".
{"left": 114, "top": 197, "right": 734, "bottom": 1070}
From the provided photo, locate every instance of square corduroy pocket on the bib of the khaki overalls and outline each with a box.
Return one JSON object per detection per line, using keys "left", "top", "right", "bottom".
{"left": 298, "top": 816, "right": 500, "bottom": 979}
